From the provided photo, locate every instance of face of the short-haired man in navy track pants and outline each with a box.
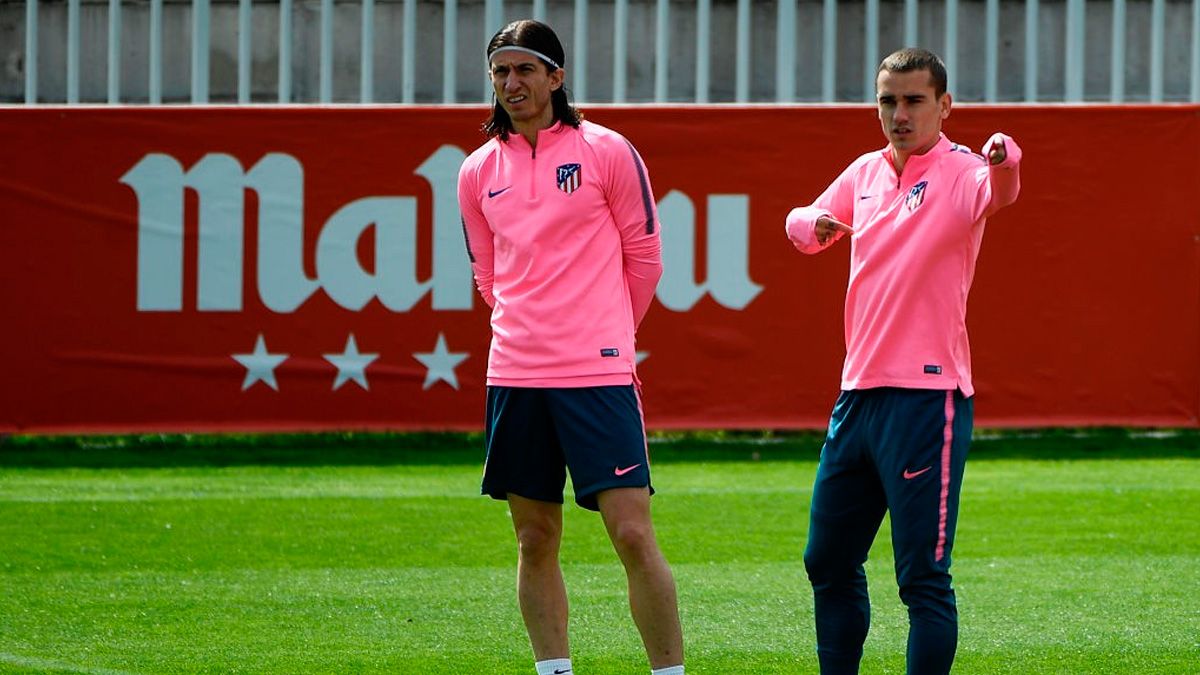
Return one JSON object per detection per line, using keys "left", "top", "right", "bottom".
{"left": 875, "top": 70, "right": 950, "bottom": 155}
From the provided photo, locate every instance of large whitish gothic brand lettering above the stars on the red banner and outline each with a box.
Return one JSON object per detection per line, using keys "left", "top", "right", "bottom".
{"left": 120, "top": 145, "right": 762, "bottom": 313}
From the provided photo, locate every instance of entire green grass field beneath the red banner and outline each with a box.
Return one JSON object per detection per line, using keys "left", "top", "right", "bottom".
{"left": 0, "top": 431, "right": 1200, "bottom": 675}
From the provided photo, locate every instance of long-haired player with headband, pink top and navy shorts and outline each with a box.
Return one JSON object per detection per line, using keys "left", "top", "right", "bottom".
{"left": 458, "top": 20, "right": 684, "bottom": 675}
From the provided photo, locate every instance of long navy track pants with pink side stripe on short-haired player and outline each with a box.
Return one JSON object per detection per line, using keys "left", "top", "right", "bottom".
{"left": 804, "top": 388, "right": 974, "bottom": 675}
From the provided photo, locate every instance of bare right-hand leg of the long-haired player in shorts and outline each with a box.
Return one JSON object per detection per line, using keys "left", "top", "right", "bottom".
{"left": 598, "top": 488, "right": 683, "bottom": 668}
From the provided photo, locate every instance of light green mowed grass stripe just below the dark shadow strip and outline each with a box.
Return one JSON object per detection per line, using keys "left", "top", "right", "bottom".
{"left": 0, "top": 450, "right": 1200, "bottom": 502}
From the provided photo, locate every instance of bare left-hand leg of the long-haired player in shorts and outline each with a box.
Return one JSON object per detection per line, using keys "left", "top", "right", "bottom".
{"left": 509, "top": 494, "right": 570, "bottom": 661}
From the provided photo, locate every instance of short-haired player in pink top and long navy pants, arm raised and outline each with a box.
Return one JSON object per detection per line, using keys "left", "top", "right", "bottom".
{"left": 786, "top": 49, "right": 1021, "bottom": 675}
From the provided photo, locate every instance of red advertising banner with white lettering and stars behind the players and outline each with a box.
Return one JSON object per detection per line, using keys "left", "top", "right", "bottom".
{"left": 0, "top": 106, "right": 1200, "bottom": 432}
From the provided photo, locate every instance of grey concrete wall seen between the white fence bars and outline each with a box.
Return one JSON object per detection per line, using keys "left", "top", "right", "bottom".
{"left": 0, "top": 0, "right": 1200, "bottom": 103}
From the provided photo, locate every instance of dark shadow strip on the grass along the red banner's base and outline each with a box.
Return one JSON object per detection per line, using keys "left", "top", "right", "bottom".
{"left": 0, "top": 429, "right": 1200, "bottom": 468}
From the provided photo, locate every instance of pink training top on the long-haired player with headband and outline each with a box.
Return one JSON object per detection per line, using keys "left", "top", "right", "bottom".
{"left": 458, "top": 121, "right": 662, "bottom": 387}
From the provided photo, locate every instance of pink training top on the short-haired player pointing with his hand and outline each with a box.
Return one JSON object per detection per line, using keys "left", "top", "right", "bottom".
{"left": 786, "top": 133, "right": 1021, "bottom": 396}
